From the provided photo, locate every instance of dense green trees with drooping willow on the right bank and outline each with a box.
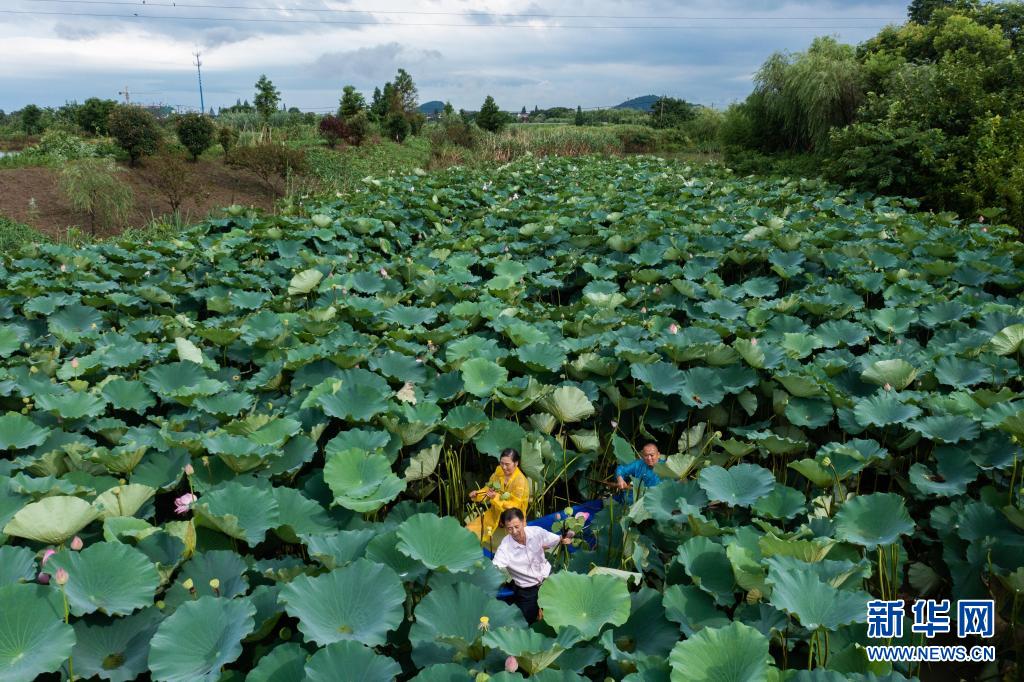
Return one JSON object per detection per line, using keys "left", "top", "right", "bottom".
{"left": 722, "top": 0, "right": 1024, "bottom": 227}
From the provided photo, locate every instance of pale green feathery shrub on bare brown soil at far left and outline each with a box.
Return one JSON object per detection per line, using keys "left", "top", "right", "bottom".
{"left": 60, "top": 159, "right": 132, "bottom": 236}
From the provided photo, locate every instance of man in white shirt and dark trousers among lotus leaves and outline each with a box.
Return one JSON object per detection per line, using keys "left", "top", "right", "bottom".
{"left": 494, "top": 507, "right": 572, "bottom": 623}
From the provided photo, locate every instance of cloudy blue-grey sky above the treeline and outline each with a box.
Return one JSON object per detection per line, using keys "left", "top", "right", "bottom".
{"left": 0, "top": 0, "right": 907, "bottom": 112}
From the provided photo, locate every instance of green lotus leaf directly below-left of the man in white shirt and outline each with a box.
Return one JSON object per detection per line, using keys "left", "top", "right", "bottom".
{"left": 409, "top": 583, "right": 526, "bottom": 656}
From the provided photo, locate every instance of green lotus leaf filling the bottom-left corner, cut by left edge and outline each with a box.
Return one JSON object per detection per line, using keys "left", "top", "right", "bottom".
{"left": 0, "top": 585, "right": 75, "bottom": 682}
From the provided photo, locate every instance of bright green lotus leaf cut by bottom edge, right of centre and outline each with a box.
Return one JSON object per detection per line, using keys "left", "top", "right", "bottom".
{"left": 669, "top": 622, "right": 768, "bottom": 682}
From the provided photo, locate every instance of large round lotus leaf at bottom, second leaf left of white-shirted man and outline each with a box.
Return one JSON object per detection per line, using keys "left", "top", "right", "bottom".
{"left": 278, "top": 559, "right": 406, "bottom": 646}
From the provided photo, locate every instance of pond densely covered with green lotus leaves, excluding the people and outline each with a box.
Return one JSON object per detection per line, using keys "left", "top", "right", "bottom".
{"left": 0, "top": 158, "right": 1024, "bottom": 682}
